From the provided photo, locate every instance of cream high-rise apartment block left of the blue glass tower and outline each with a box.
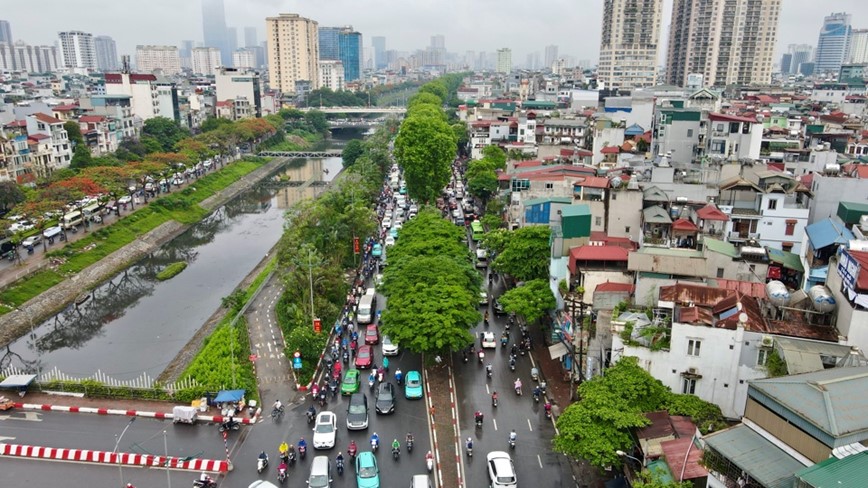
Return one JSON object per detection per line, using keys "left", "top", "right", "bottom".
{"left": 265, "top": 14, "right": 320, "bottom": 93}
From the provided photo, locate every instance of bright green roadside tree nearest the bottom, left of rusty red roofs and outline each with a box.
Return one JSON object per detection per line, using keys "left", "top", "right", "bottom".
{"left": 554, "top": 356, "right": 670, "bottom": 468}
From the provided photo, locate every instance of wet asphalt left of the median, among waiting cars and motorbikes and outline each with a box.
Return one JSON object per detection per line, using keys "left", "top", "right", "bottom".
{"left": 227, "top": 347, "right": 431, "bottom": 486}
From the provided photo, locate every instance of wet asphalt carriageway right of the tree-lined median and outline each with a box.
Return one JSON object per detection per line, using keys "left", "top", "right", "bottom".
{"left": 453, "top": 237, "right": 572, "bottom": 487}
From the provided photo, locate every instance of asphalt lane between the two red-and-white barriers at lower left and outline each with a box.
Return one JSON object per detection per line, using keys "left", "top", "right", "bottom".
{"left": 0, "top": 410, "right": 237, "bottom": 459}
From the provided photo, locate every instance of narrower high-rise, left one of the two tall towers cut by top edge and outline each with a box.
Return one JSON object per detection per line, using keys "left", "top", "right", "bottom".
{"left": 597, "top": 0, "right": 663, "bottom": 90}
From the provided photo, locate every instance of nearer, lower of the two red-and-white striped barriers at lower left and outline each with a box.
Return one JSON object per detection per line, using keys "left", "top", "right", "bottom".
{"left": 0, "top": 443, "right": 229, "bottom": 473}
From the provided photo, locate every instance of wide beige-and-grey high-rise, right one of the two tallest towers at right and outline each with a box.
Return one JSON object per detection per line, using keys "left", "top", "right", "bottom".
{"left": 666, "top": 0, "right": 781, "bottom": 86}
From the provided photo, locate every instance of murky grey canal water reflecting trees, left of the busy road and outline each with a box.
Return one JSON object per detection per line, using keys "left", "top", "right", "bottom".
{"left": 4, "top": 133, "right": 361, "bottom": 380}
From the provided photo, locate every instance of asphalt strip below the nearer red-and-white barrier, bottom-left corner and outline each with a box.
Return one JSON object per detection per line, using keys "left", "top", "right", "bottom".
{"left": 0, "top": 457, "right": 214, "bottom": 487}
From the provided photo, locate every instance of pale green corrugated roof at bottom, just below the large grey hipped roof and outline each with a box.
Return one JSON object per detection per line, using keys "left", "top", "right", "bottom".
{"left": 705, "top": 424, "right": 805, "bottom": 488}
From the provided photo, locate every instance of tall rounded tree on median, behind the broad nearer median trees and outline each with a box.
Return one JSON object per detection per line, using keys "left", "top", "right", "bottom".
{"left": 395, "top": 116, "right": 455, "bottom": 202}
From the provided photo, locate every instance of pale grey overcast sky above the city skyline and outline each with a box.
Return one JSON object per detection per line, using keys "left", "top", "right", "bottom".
{"left": 0, "top": 0, "right": 868, "bottom": 64}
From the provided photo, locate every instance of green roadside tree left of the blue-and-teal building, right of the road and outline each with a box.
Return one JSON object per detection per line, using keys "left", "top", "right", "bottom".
{"left": 493, "top": 225, "right": 551, "bottom": 281}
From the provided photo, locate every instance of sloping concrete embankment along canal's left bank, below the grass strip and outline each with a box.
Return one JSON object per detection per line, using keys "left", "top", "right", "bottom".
{"left": 0, "top": 158, "right": 286, "bottom": 347}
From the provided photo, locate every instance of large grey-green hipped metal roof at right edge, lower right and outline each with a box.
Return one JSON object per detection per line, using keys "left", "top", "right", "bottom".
{"left": 748, "top": 366, "right": 868, "bottom": 440}
